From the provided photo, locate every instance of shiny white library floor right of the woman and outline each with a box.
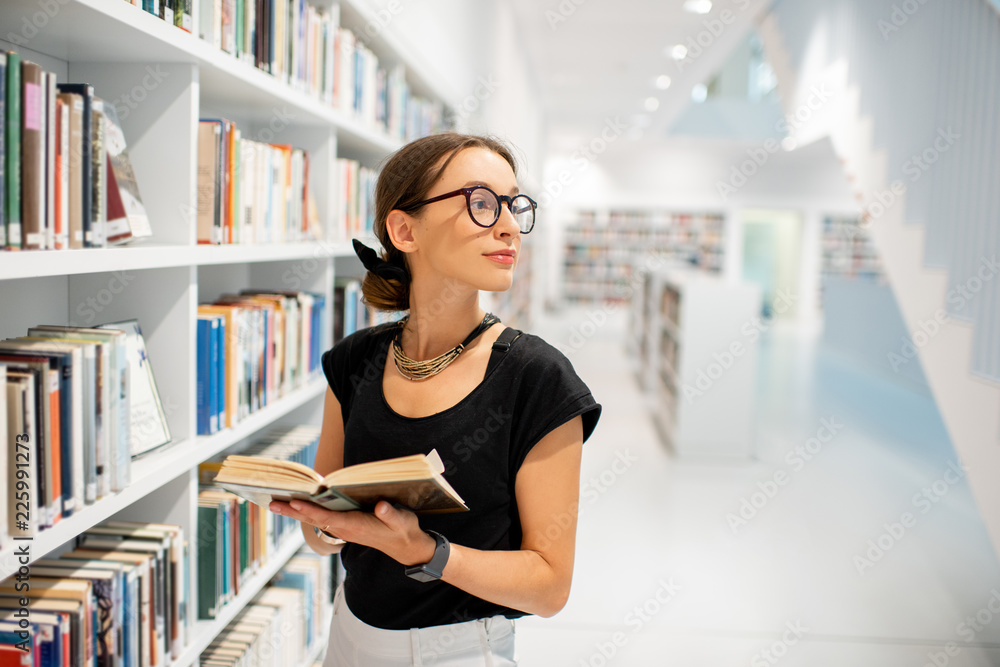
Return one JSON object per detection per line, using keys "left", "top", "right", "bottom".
{"left": 517, "top": 310, "right": 1000, "bottom": 667}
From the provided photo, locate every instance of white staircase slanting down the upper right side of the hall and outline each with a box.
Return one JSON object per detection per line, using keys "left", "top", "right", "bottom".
{"left": 759, "top": 0, "right": 1000, "bottom": 553}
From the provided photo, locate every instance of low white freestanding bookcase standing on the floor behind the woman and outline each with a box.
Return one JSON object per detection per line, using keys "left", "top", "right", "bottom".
{"left": 631, "top": 269, "right": 761, "bottom": 460}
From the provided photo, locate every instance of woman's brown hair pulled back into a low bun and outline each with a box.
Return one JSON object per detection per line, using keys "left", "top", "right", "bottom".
{"left": 361, "top": 132, "right": 517, "bottom": 310}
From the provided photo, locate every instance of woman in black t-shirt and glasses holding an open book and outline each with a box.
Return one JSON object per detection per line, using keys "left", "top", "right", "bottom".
{"left": 271, "top": 134, "right": 601, "bottom": 667}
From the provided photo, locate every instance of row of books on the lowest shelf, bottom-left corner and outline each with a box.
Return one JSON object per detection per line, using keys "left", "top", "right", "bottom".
{"left": 0, "top": 521, "right": 194, "bottom": 667}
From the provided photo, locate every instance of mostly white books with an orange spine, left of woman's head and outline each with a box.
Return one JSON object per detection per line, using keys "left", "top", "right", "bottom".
{"left": 198, "top": 118, "right": 321, "bottom": 244}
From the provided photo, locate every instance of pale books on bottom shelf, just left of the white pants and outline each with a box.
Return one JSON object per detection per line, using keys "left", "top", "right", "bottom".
{"left": 199, "top": 547, "right": 333, "bottom": 667}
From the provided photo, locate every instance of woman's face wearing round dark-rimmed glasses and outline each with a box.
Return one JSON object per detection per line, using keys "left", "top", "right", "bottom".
{"left": 408, "top": 148, "right": 521, "bottom": 292}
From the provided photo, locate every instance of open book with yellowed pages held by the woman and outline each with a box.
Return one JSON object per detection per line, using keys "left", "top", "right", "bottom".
{"left": 215, "top": 450, "right": 469, "bottom": 514}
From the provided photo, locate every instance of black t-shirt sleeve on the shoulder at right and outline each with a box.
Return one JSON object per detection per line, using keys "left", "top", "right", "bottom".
{"left": 510, "top": 338, "right": 601, "bottom": 479}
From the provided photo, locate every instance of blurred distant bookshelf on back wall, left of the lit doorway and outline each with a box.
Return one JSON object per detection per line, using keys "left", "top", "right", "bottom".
{"left": 562, "top": 209, "right": 726, "bottom": 303}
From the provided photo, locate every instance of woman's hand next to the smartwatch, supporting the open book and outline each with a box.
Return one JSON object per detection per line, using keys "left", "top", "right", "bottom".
{"left": 268, "top": 500, "right": 435, "bottom": 566}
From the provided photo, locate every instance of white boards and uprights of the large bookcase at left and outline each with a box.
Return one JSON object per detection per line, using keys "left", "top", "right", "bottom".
{"left": 0, "top": 0, "right": 457, "bottom": 667}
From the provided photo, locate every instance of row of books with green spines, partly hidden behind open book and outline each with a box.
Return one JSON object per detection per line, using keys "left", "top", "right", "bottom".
{"left": 197, "top": 426, "right": 319, "bottom": 619}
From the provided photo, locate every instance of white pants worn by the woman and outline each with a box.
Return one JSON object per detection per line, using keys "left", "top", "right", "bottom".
{"left": 323, "top": 587, "right": 517, "bottom": 667}
